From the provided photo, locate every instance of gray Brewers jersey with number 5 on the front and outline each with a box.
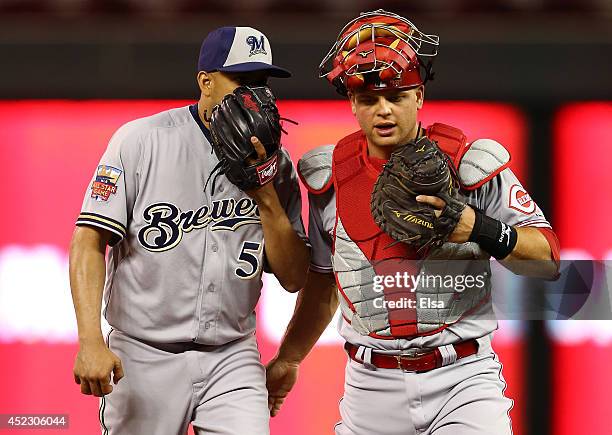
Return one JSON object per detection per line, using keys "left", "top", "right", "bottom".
{"left": 77, "top": 105, "right": 306, "bottom": 345}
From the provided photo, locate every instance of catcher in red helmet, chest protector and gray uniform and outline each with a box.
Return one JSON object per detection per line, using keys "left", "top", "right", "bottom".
{"left": 266, "top": 10, "right": 559, "bottom": 435}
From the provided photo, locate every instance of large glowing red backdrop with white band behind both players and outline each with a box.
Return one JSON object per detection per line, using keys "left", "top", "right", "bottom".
{"left": 0, "top": 101, "right": 524, "bottom": 435}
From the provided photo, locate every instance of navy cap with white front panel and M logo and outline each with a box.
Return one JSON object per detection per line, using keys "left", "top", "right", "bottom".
{"left": 198, "top": 27, "right": 291, "bottom": 78}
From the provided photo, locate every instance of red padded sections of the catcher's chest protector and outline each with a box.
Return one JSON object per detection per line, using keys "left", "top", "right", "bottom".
{"left": 332, "top": 123, "right": 468, "bottom": 338}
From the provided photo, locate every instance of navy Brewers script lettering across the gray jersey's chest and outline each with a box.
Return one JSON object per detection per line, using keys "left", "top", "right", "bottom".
{"left": 138, "top": 198, "right": 261, "bottom": 252}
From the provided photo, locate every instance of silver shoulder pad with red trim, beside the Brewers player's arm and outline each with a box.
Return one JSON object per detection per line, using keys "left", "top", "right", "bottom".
{"left": 297, "top": 145, "right": 334, "bottom": 195}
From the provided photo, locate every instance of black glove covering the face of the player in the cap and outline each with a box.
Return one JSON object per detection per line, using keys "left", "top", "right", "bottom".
{"left": 210, "top": 86, "right": 282, "bottom": 191}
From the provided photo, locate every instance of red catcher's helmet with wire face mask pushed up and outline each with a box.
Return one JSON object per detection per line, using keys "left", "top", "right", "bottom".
{"left": 319, "top": 9, "right": 439, "bottom": 95}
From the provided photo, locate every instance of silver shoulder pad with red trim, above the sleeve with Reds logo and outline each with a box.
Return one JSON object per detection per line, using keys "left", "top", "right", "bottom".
{"left": 459, "top": 139, "right": 510, "bottom": 190}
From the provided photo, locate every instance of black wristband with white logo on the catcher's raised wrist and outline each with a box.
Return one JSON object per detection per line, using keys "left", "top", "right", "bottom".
{"left": 468, "top": 208, "right": 518, "bottom": 260}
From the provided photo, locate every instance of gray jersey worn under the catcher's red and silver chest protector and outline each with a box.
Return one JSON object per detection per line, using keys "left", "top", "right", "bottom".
{"left": 309, "top": 145, "right": 550, "bottom": 351}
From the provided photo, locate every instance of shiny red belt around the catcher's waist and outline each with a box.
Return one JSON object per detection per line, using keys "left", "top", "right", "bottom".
{"left": 344, "top": 339, "right": 478, "bottom": 372}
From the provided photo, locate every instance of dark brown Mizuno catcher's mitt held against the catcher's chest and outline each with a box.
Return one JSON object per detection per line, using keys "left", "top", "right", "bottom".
{"left": 370, "top": 137, "right": 465, "bottom": 252}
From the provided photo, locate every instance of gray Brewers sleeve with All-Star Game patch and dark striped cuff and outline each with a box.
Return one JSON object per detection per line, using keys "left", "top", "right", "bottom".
{"left": 76, "top": 124, "right": 139, "bottom": 245}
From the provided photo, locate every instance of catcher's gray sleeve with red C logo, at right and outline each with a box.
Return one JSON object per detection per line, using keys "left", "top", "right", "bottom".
{"left": 478, "top": 168, "right": 551, "bottom": 228}
